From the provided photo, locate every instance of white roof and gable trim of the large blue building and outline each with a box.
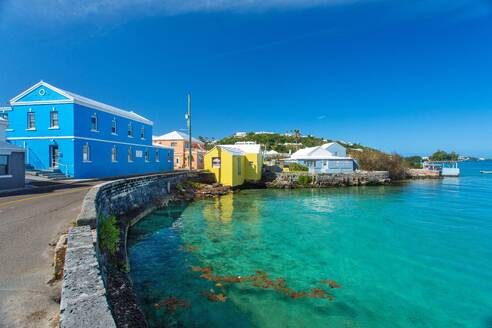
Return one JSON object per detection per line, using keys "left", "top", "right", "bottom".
{"left": 10, "top": 81, "right": 154, "bottom": 125}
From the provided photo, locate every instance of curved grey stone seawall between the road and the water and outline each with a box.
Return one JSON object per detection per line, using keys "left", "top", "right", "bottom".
{"left": 60, "top": 172, "right": 191, "bottom": 328}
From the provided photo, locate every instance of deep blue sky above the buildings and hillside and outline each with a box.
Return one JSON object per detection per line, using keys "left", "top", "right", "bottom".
{"left": 0, "top": 0, "right": 492, "bottom": 156}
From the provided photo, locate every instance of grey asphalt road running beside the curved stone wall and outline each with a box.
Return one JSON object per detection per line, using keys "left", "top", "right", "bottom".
{"left": 0, "top": 181, "right": 99, "bottom": 328}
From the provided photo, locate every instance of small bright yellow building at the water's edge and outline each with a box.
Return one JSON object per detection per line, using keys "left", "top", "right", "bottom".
{"left": 205, "top": 142, "right": 263, "bottom": 187}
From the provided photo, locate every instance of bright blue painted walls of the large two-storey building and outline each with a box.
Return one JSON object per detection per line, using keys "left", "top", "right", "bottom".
{"left": 7, "top": 86, "right": 174, "bottom": 178}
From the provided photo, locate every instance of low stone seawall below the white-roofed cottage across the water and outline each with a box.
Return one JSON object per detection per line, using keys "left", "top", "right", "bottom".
{"left": 267, "top": 171, "right": 391, "bottom": 188}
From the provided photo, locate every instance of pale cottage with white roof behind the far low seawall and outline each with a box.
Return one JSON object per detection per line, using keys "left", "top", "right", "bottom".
{"left": 289, "top": 142, "right": 357, "bottom": 173}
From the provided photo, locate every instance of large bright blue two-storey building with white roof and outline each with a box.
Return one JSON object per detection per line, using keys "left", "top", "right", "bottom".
{"left": 0, "top": 81, "right": 174, "bottom": 178}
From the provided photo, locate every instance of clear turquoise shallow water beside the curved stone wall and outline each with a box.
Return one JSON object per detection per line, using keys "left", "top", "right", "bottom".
{"left": 128, "top": 162, "right": 492, "bottom": 327}
